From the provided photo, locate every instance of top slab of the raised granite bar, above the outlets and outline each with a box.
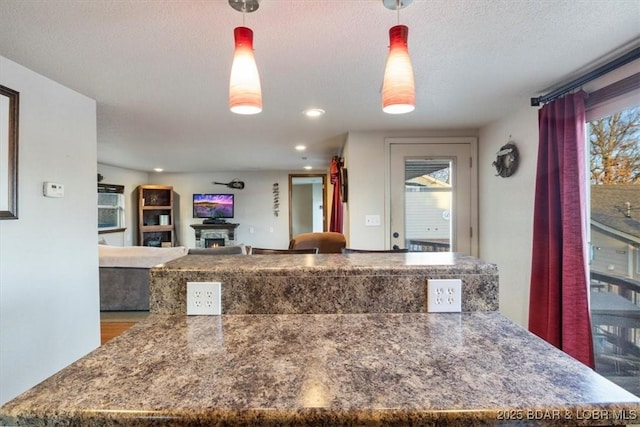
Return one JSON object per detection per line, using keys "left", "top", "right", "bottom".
{"left": 152, "top": 252, "right": 498, "bottom": 277}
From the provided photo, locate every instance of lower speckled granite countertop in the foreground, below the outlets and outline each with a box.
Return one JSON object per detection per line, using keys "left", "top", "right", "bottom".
{"left": 0, "top": 312, "right": 640, "bottom": 427}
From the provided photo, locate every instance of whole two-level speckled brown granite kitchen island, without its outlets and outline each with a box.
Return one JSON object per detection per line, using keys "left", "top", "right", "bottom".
{"left": 0, "top": 253, "right": 640, "bottom": 427}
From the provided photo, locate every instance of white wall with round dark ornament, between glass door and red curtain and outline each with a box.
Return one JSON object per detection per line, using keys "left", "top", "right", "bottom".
{"left": 478, "top": 105, "right": 538, "bottom": 326}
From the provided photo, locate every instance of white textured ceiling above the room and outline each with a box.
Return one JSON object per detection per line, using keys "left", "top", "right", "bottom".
{"left": 0, "top": 0, "right": 640, "bottom": 172}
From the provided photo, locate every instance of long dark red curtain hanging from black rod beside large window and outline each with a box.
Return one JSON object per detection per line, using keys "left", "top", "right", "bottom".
{"left": 529, "top": 92, "right": 595, "bottom": 368}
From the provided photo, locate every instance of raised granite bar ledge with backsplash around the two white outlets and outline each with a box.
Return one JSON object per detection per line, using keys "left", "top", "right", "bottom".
{"left": 150, "top": 252, "right": 498, "bottom": 314}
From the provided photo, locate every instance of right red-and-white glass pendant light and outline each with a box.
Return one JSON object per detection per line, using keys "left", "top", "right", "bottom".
{"left": 382, "top": 0, "right": 416, "bottom": 114}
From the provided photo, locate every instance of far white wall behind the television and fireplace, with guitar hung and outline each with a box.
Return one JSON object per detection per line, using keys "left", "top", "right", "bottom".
{"left": 149, "top": 171, "right": 293, "bottom": 249}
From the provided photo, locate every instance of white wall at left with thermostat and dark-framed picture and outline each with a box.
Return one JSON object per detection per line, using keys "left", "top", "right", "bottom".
{"left": 0, "top": 56, "right": 100, "bottom": 404}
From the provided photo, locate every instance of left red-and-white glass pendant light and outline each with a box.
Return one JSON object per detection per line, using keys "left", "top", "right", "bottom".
{"left": 229, "top": 0, "right": 262, "bottom": 114}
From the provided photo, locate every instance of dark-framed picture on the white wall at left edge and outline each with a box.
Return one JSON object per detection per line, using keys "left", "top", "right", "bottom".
{"left": 0, "top": 85, "right": 20, "bottom": 219}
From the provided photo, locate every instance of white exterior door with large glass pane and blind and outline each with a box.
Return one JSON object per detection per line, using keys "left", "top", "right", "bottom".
{"left": 387, "top": 138, "right": 477, "bottom": 255}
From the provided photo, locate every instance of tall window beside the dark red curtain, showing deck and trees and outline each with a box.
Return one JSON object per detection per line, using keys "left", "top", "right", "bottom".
{"left": 587, "top": 103, "right": 640, "bottom": 395}
